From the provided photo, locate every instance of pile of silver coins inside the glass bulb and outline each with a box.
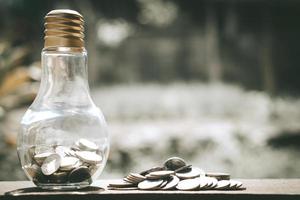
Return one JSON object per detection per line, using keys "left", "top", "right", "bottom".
{"left": 24, "top": 138, "right": 102, "bottom": 184}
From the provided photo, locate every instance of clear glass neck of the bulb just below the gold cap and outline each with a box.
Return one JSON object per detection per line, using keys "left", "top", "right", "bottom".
{"left": 34, "top": 50, "right": 93, "bottom": 109}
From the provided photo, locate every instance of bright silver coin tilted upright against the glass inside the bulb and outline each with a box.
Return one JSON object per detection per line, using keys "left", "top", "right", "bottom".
{"left": 41, "top": 154, "right": 61, "bottom": 175}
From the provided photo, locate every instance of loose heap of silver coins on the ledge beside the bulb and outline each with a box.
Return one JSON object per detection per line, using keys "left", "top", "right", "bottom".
{"left": 108, "top": 157, "right": 245, "bottom": 191}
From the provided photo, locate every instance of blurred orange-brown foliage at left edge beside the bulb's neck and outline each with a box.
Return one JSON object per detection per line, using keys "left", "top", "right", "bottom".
{"left": 0, "top": 43, "right": 41, "bottom": 110}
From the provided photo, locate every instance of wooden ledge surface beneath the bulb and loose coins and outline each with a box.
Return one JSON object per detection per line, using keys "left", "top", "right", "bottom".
{"left": 0, "top": 179, "right": 300, "bottom": 200}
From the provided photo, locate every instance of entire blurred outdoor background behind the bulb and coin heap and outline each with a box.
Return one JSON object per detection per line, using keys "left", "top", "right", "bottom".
{"left": 0, "top": 0, "right": 300, "bottom": 180}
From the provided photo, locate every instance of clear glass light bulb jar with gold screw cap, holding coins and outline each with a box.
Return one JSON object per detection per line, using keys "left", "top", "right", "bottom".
{"left": 17, "top": 10, "right": 109, "bottom": 189}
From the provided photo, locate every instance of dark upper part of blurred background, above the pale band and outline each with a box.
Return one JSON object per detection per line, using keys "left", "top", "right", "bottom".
{"left": 0, "top": 0, "right": 300, "bottom": 95}
